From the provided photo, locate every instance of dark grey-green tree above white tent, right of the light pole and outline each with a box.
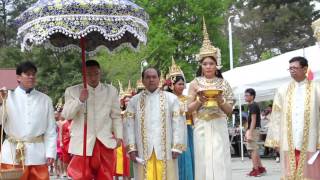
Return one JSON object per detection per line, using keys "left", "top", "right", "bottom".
{"left": 236, "top": 0, "right": 319, "bottom": 64}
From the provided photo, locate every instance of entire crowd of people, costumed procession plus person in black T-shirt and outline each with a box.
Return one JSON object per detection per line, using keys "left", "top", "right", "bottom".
{"left": 0, "top": 19, "right": 320, "bottom": 180}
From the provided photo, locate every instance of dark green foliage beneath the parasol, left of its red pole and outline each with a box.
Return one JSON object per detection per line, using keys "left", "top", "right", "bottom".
{"left": 0, "top": 47, "right": 82, "bottom": 102}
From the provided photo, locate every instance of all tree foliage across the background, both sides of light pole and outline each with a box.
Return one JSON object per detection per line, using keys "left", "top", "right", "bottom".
{"left": 0, "top": 0, "right": 320, "bottom": 100}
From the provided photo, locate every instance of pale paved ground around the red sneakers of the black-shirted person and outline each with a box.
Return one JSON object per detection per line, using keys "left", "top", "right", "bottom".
{"left": 50, "top": 158, "right": 280, "bottom": 180}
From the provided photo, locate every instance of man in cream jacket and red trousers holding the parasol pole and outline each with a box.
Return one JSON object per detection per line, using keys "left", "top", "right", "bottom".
{"left": 62, "top": 60, "right": 122, "bottom": 180}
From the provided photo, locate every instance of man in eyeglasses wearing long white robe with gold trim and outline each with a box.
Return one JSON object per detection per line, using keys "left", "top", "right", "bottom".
{"left": 265, "top": 57, "right": 320, "bottom": 180}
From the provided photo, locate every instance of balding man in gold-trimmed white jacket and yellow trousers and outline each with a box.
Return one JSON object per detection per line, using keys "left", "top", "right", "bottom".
{"left": 124, "top": 68, "right": 186, "bottom": 180}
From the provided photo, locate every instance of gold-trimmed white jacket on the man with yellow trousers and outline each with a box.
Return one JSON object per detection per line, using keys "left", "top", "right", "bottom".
{"left": 124, "top": 89, "right": 186, "bottom": 160}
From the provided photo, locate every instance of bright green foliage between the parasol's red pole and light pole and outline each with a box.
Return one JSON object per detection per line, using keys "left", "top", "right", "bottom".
{"left": 97, "top": 0, "right": 232, "bottom": 84}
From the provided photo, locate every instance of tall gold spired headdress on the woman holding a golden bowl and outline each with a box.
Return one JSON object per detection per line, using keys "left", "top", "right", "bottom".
{"left": 197, "top": 18, "right": 222, "bottom": 69}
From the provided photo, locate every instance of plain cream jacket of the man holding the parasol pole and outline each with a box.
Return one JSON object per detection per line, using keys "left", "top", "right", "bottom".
{"left": 62, "top": 83, "right": 122, "bottom": 156}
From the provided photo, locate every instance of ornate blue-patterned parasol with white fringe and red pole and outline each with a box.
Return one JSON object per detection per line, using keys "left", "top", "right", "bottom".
{"left": 16, "top": 0, "right": 149, "bottom": 178}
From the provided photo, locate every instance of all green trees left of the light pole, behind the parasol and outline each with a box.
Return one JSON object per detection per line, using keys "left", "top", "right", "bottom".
{"left": 0, "top": 0, "right": 233, "bottom": 100}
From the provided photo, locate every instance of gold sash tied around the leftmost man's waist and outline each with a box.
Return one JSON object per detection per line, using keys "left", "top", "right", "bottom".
{"left": 7, "top": 135, "right": 44, "bottom": 164}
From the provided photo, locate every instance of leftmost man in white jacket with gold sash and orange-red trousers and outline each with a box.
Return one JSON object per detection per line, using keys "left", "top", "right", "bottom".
{"left": 0, "top": 61, "right": 57, "bottom": 180}
